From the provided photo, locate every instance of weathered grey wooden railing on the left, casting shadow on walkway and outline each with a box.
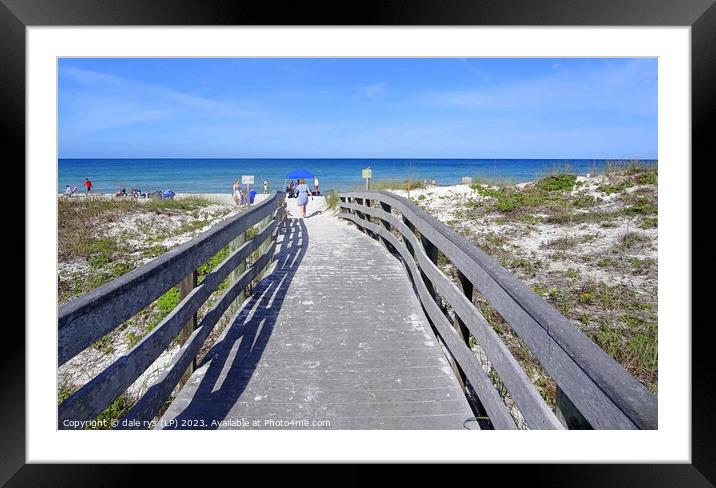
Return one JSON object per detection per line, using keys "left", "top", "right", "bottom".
{"left": 58, "top": 192, "right": 286, "bottom": 428}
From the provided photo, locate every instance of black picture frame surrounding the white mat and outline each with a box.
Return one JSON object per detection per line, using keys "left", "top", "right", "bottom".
{"left": 5, "top": 0, "right": 716, "bottom": 487}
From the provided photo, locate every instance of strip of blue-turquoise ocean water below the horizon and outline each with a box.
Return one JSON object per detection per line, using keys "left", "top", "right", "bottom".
{"left": 57, "top": 159, "right": 657, "bottom": 193}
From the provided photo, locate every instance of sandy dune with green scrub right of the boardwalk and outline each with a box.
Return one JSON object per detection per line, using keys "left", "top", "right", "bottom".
{"left": 442, "top": 168, "right": 658, "bottom": 393}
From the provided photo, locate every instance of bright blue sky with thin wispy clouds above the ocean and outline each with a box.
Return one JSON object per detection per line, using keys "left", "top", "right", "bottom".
{"left": 58, "top": 58, "right": 657, "bottom": 159}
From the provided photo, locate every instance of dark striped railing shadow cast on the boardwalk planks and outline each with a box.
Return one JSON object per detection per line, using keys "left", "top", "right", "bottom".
{"left": 164, "top": 218, "right": 308, "bottom": 430}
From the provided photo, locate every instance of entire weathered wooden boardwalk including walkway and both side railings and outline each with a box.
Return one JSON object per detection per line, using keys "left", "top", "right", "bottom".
{"left": 57, "top": 191, "right": 658, "bottom": 430}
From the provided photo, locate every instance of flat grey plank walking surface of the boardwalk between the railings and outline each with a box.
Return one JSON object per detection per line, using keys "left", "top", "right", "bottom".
{"left": 158, "top": 207, "right": 476, "bottom": 429}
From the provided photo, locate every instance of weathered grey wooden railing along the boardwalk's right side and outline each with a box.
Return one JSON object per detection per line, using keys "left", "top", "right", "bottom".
{"left": 338, "top": 191, "right": 657, "bottom": 429}
